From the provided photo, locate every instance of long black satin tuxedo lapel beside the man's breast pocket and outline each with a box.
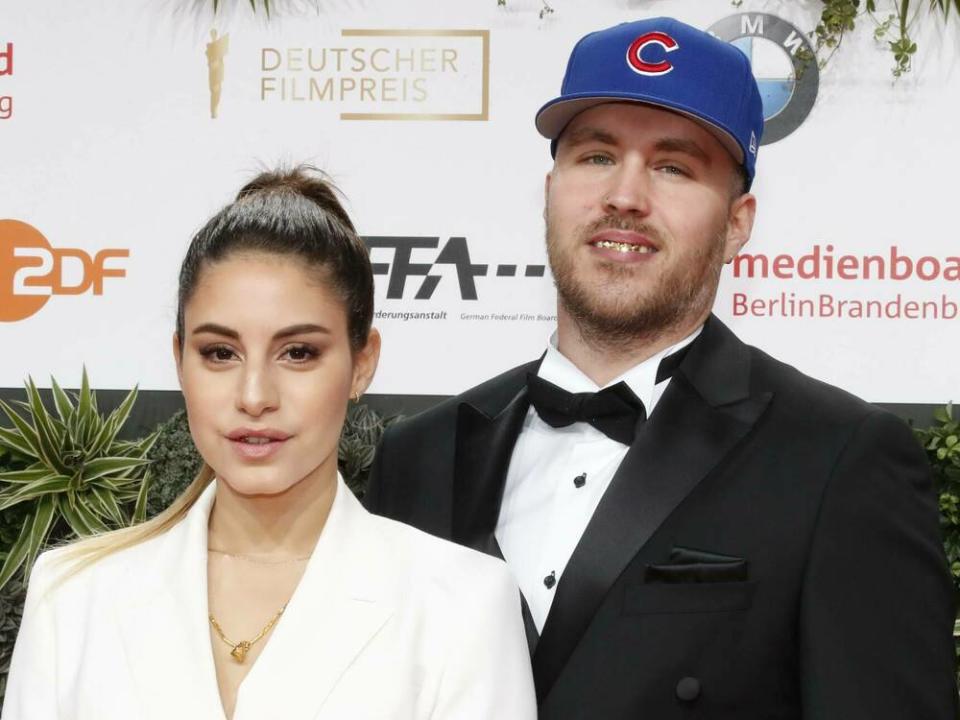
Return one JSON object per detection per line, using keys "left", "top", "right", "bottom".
{"left": 534, "top": 316, "right": 771, "bottom": 702}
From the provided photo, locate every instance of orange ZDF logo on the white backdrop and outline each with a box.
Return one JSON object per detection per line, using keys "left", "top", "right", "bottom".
{"left": 0, "top": 220, "right": 130, "bottom": 322}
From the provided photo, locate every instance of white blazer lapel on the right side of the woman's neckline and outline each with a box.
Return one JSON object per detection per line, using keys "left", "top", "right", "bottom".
{"left": 234, "top": 480, "right": 396, "bottom": 720}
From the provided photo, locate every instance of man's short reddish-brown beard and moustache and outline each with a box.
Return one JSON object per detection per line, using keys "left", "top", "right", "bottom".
{"left": 545, "top": 212, "right": 726, "bottom": 349}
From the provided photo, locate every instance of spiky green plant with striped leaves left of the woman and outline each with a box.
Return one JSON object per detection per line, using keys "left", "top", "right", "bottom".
{"left": 0, "top": 370, "right": 156, "bottom": 589}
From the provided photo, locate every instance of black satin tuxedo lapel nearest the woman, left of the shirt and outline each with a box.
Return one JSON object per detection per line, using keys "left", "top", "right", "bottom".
{"left": 452, "top": 386, "right": 530, "bottom": 558}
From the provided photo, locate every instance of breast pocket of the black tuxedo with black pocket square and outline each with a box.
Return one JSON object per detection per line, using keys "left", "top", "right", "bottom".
{"left": 623, "top": 582, "right": 756, "bottom": 615}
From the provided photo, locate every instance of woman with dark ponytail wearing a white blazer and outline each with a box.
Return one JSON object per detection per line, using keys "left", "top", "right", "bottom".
{"left": 3, "top": 169, "right": 536, "bottom": 720}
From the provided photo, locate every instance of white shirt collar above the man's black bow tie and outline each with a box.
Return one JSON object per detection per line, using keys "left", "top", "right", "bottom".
{"left": 537, "top": 325, "right": 703, "bottom": 415}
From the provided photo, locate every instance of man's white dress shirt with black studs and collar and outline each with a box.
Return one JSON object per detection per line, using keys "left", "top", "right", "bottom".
{"left": 496, "top": 326, "right": 702, "bottom": 631}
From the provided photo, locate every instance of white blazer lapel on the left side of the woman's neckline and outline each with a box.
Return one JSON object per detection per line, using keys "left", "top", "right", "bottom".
{"left": 116, "top": 483, "right": 223, "bottom": 720}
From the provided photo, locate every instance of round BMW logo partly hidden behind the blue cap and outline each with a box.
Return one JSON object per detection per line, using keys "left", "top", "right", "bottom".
{"left": 707, "top": 13, "right": 820, "bottom": 149}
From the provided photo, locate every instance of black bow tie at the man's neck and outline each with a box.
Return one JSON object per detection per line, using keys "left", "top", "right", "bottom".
{"left": 527, "top": 346, "right": 689, "bottom": 445}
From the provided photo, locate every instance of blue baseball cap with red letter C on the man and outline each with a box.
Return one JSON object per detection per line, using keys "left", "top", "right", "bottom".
{"left": 536, "top": 17, "right": 763, "bottom": 188}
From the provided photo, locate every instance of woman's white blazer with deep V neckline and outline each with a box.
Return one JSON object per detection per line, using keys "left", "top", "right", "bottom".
{"left": 2, "top": 480, "right": 536, "bottom": 720}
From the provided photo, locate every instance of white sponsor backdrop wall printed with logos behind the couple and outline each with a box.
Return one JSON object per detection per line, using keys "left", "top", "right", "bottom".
{"left": 0, "top": 0, "right": 960, "bottom": 403}
